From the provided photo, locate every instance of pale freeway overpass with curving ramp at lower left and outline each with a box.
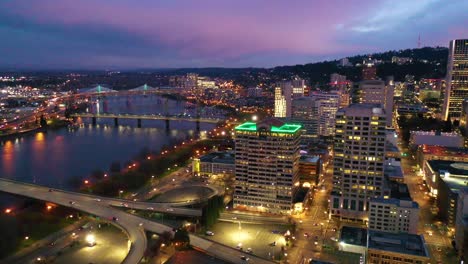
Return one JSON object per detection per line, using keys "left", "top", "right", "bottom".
{"left": 0, "top": 179, "right": 273, "bottom": 264}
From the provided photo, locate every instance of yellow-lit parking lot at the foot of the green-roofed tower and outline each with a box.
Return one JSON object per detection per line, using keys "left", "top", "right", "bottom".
{"left": 207, "top": 222, "right": 288, "bottom": 259}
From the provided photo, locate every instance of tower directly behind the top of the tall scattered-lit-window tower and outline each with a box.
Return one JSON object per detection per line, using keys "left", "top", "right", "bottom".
{"left": 359, "top": 80, "right": 395, "bottom": 127}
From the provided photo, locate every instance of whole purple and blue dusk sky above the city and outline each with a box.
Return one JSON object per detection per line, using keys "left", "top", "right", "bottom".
{"left": 0, "top": 0, "right": 468, "bottom": 69}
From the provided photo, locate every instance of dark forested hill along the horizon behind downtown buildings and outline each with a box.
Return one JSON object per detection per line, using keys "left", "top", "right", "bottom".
{"left": 156, "top": 47, "right": 448, "bottom": 86}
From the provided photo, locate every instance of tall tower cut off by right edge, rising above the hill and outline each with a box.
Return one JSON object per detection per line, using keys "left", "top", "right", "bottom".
{"left": 442, "top": 39, "right": 468, "bottom": 120}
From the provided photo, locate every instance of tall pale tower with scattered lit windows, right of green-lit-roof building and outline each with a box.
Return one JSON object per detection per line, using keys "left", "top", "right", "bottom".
{"left": 330, "top": 104, "right": 389, "bottom": 221}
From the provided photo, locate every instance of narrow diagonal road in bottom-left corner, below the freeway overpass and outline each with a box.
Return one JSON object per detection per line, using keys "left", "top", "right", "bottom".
{"left": 0, "top": 217, "right": 89, "bottom": 264}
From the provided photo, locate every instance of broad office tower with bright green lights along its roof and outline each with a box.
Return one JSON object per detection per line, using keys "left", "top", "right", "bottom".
{"left": 234, "top": 118, "right": 302, "bottom": 213}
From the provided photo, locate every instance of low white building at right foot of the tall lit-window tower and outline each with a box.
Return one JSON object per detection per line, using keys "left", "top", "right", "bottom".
{"left": 369, "top": 198, "right": 419, "bottom": 234}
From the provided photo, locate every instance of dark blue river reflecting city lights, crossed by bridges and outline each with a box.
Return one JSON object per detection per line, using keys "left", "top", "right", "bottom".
{"left": 0, "top": 95, "right": 220, "bottom": 189}
